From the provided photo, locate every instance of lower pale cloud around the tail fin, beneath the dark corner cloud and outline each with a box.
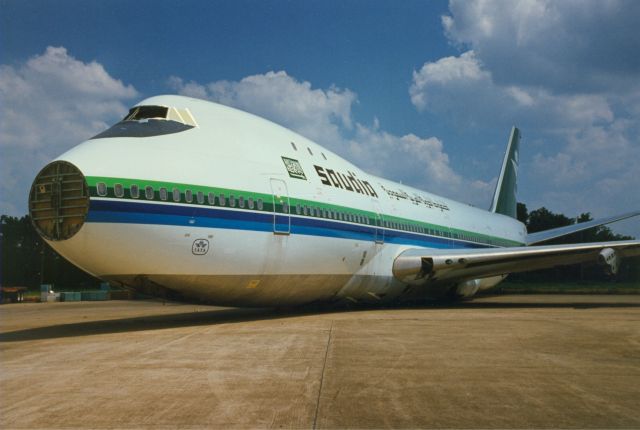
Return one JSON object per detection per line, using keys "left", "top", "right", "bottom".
{"left": 409, "top": 48, "right": 640, "bottom": 220}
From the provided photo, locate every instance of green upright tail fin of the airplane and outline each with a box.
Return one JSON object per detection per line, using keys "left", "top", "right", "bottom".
{"left": 490, "top": 126, "right": 520, "bottom": 218}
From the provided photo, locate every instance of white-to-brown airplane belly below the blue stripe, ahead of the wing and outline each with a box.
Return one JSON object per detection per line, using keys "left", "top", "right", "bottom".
{"left": 51, "top": 223, "right": 410, "bottom": 306}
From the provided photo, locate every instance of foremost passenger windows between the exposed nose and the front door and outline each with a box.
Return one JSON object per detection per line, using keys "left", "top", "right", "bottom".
{"left": 96, "top": 182, "right": 264, "bottom": 210}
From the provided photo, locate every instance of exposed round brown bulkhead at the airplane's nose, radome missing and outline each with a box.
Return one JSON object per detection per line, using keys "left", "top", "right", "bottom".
{"left": 29, "top": 161, "right": 89, "bottom": 241}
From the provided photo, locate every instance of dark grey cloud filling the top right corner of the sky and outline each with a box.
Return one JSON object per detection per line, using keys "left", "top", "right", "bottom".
{"left": 442, "top": 0, "right": 640, "bottom": 94}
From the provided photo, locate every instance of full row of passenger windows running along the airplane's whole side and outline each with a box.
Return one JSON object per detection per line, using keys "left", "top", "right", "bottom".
{"left": 96, "top": 182, "right": 499, "bottom": 245}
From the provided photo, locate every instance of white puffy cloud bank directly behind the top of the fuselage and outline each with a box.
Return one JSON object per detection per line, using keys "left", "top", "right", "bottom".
{"left": 169, "top": 71, "right": 491, "bottom": 205}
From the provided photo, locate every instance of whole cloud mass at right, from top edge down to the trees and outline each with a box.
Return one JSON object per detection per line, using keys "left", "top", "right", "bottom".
{"left": 409, "top": 0, "right": 640, "bottom": 222}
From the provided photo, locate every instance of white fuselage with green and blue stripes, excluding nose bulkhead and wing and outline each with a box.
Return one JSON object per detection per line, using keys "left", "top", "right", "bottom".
{"left": 42, "top": 96, "right": 526, "bottom": 306}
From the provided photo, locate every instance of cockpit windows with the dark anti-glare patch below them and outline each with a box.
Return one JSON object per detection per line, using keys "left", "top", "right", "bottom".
{"left": 92, "top": 105, "right": 198, "bottom": 139}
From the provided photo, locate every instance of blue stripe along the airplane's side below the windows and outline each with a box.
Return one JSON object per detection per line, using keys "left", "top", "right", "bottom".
{"left": 87, "top": 199, "right": 489, "bottom": 248}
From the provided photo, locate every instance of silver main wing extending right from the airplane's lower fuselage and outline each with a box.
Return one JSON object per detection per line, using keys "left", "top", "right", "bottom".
{"left": 393, "top": 240, "right": 640, "bottom": 284}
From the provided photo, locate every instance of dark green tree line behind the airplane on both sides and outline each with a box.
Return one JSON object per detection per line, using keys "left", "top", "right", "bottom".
{"left": 0, "top": 207, "right": 640, "bottom": 289}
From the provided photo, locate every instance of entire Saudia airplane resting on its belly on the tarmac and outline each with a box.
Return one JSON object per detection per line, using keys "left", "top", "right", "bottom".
{"left": 29, "top": 96, "right": 640, "bottom": 306}
